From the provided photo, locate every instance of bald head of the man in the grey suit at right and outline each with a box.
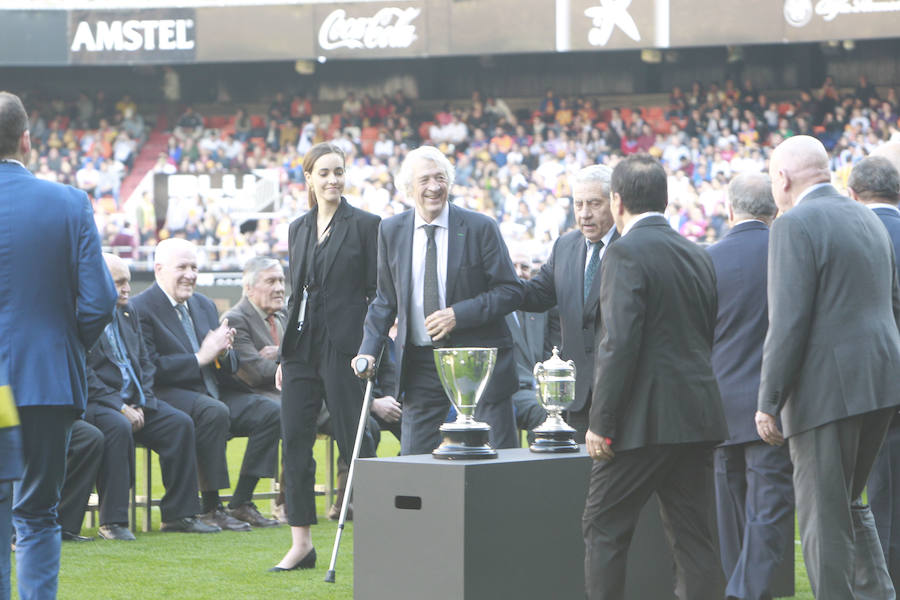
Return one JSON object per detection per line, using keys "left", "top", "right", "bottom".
{"left": 769, "top": 135, "right": 831, "bottom": 212}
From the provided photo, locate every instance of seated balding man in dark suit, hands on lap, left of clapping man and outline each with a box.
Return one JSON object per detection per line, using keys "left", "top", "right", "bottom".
{"left": 86, "top": 254, "right": 220, "bottom": 541}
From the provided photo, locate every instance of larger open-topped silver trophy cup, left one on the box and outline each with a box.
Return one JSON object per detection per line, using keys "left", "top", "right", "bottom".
{"left": 431, "top": 348, "right": 497, "bottom": 460}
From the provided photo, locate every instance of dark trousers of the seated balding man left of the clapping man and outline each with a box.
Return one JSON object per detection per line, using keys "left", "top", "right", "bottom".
{"left": 87, "top": 400, "right": 200, "bottom": 525}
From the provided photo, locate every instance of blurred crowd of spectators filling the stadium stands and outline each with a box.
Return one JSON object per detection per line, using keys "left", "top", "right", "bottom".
{"left": 29, "top": 76, "right": 900, "bottom": 268}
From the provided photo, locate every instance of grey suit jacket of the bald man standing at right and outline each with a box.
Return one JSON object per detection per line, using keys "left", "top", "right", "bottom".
{"left": 758, "top": 185, "right": 900, "bottom": 436}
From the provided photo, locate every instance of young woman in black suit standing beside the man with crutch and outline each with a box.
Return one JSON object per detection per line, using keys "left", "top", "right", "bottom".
{"left": 271, "top": 143, "right": 381, "bottom": 571}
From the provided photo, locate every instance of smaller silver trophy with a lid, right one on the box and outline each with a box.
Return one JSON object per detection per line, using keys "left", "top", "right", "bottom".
{"left": 530, "top": 346, "right": 578, "bottom": 452}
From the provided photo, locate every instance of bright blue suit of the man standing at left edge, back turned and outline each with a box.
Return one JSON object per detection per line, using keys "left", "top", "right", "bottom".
{"left": 0, "top": 162, "right": 116, "bottom": 600}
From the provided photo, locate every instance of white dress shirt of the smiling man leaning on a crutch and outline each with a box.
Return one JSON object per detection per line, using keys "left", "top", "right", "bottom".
{"left": 409, "top": 202, "right": 450, "bottom": 346}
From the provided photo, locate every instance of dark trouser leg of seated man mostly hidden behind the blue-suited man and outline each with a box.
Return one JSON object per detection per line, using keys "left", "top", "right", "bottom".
{"left": 57, "top": 419, "right": 103, "bottom": 535}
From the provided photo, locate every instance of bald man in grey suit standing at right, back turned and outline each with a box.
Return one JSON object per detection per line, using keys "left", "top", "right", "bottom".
{"left": 756, "top": 136, "right": 900, "bottom": 600}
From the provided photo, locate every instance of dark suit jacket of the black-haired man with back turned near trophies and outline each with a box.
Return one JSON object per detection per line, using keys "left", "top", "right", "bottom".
{"left": 590, "top": 216, "right": 728, "bottom": 451}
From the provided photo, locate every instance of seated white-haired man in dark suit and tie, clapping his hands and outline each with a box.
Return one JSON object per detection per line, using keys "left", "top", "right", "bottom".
{"left": 132, "top": 238, "right": 281, "bottom": 531}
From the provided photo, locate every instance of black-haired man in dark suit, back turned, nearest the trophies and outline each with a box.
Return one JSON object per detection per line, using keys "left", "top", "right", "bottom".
{"left": 583, "top": 154, "right": 728, "bottom": 600}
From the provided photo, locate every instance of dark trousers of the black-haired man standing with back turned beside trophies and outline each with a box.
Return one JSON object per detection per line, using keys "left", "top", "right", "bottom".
{"left": 582, "top": 444, "right": 721, "bottom": 600}
